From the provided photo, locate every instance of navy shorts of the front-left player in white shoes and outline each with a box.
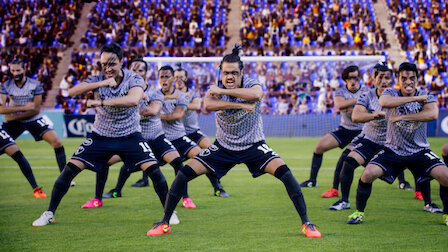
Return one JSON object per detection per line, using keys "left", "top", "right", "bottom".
{"left": 72, "top": 132, "right": 157, "bottom": 172}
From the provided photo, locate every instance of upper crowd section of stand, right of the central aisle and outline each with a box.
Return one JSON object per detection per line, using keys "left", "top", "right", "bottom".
{"left": 241, "top": 0, "right": 386, "bottom": 50}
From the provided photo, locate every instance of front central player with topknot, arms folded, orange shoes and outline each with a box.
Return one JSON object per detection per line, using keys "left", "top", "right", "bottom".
{"left": 147, "top": 46, "right": 321, "bottom": 238}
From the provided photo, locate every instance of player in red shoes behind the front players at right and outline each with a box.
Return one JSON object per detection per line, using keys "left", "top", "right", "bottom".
{"left": 300, "top": 65, "right": 369, "bottom": 198}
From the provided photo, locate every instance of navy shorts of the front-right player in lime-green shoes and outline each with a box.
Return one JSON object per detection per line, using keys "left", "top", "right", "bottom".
{"left": 370, "top": 147, "right": 445, "bottom": 184}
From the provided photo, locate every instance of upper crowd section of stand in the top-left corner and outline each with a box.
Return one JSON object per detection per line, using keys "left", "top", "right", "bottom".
{"left": 0, "top": 0, "right": 83, "bottom": 47}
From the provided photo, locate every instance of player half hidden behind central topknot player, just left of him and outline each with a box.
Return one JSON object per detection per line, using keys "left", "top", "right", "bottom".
{"left": 174, "top": 68, "right": 230, "bottom": 198}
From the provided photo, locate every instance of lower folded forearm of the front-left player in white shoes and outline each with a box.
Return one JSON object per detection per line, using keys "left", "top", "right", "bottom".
{"left": 87, "top": 87, "right": 143, "bottom": 108}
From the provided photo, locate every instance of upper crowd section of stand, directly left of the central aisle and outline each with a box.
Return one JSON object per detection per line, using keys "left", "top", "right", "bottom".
{"left": 82, "top": 0, "right": 228, "bottom": 50}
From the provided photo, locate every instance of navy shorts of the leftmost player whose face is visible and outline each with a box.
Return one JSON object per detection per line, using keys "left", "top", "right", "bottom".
{"left": 2, "top": 117, "right": 53, "bottom": 141}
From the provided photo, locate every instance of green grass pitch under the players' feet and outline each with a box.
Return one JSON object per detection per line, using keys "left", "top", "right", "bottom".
{"left": 0, "top": 138, "right": 448, "bottom": 251}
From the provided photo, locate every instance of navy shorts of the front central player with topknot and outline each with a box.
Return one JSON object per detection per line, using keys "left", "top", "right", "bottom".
{"left": 194, "top": 141, "right": 280, "bottom": 178}
